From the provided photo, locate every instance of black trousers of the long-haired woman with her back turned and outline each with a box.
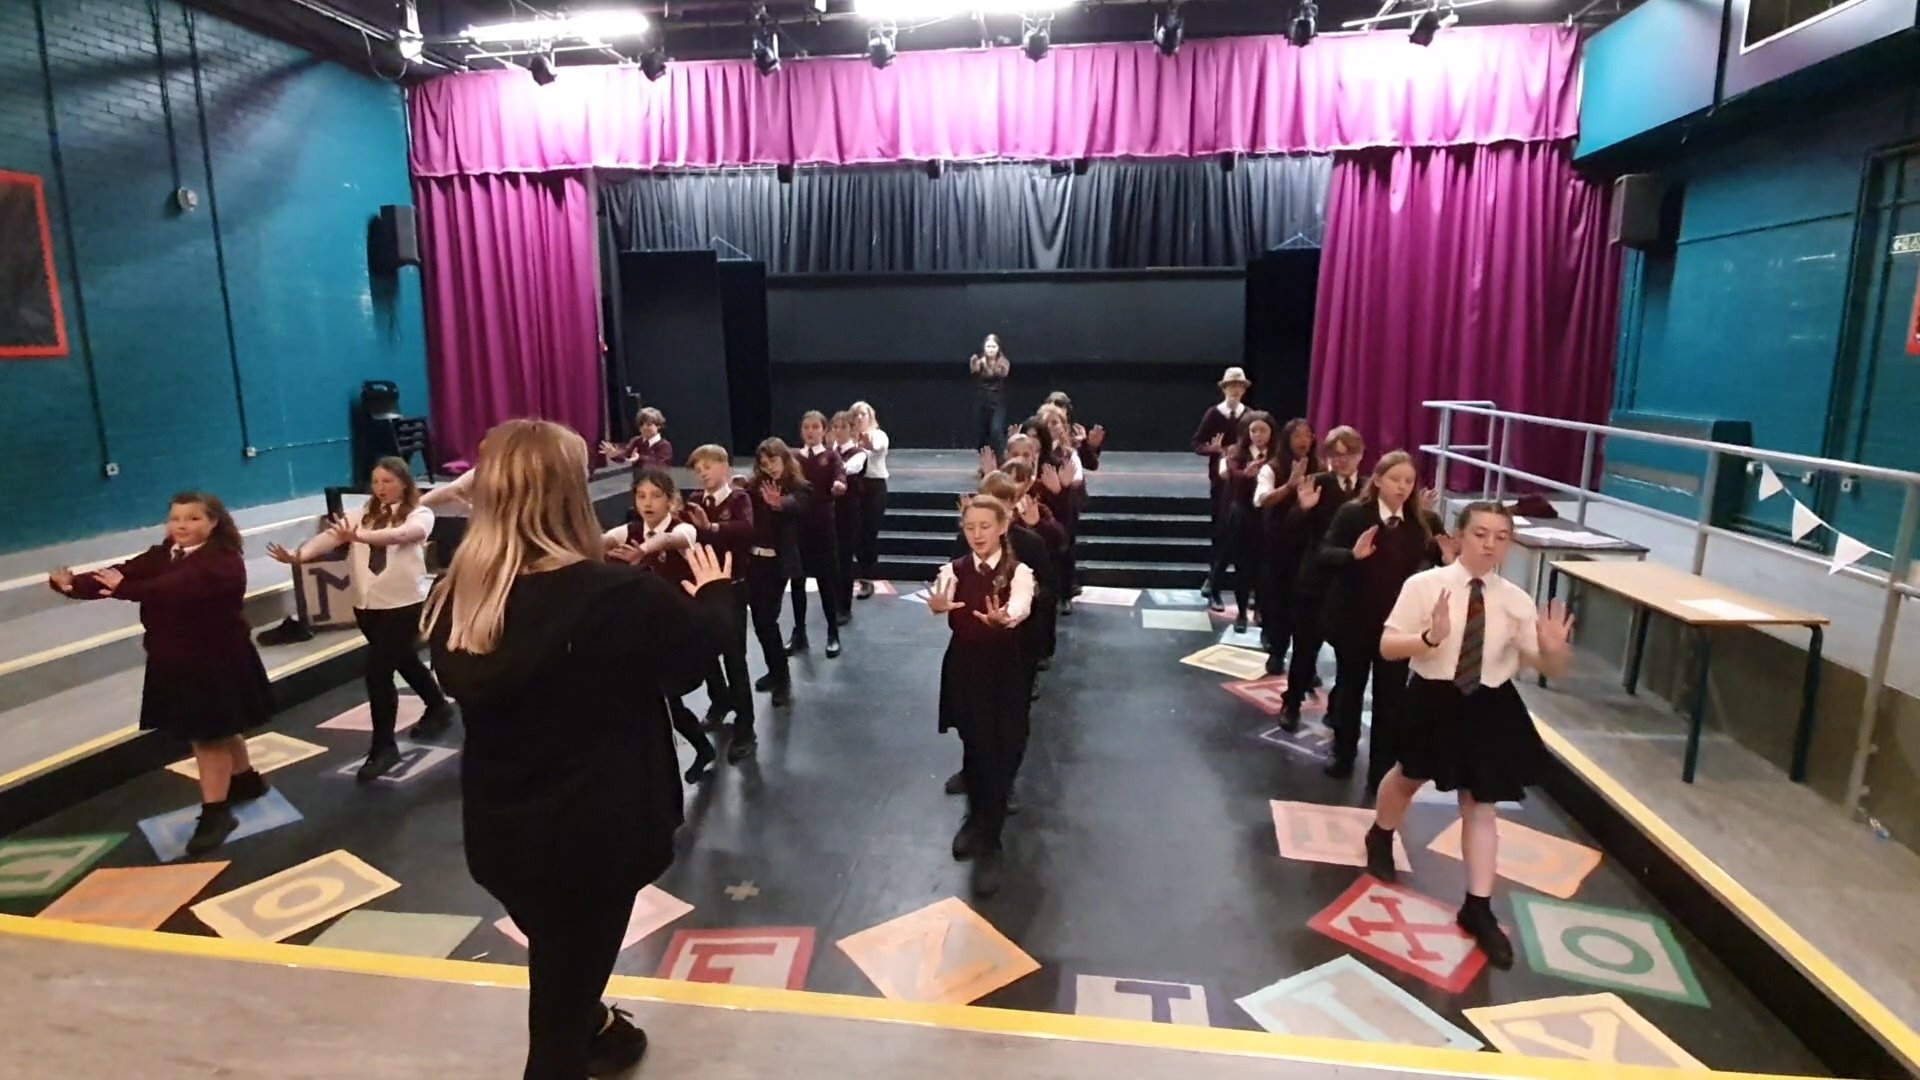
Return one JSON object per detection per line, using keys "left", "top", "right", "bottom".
{"left": 499, "top": 890, "right": 634, "bottom": 1080}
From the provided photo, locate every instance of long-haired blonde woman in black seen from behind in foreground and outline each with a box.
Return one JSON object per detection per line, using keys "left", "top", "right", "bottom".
{"left": 424, "top": 421, "right": 733, "bottom": 1080}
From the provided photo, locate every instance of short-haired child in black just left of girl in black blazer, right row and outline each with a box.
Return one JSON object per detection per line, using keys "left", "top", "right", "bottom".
{"left": 1267, "top": 425, "right": 1367, "bottom": 732}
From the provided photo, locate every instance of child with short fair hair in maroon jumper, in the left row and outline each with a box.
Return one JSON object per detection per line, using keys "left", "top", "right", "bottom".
{"left": 685, "top": 442, "right": 756, "bottom": 763}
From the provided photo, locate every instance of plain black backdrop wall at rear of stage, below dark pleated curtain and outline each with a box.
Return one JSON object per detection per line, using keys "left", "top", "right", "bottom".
{"left": 768, "top": 269, "right": 1304, "bottom": 450}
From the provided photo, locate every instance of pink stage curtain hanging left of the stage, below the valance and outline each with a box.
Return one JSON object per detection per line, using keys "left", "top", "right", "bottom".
{"left": 413, "top": 173, "right": 601, "bottom": 459}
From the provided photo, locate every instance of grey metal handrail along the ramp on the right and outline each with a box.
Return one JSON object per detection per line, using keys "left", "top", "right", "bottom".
{"left": 1421, "top": 400, "right": 1920, "bottom": 813}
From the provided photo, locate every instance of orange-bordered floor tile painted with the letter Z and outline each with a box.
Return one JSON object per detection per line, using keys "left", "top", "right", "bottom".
{"left": 839, "top": 897, "right": 1041, "bottom": 1005}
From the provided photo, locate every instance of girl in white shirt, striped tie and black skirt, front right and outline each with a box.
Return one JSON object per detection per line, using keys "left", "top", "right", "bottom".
{"left": 1367, "top": 502, "right": 1572, "bottom": 969}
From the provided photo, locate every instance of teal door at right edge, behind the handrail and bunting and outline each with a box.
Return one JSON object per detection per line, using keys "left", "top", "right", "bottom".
{"left": 1818, "top": 144, "right": 1920, "bottom": 552}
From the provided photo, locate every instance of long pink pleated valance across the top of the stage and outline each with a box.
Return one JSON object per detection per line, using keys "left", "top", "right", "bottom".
{"left": 409, "top": 25, "right": 1578, "bottom": 177}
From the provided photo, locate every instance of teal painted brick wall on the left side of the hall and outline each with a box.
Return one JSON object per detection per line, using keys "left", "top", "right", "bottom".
{"left": 0, "top": 0, "right": 426, "bottom": 550}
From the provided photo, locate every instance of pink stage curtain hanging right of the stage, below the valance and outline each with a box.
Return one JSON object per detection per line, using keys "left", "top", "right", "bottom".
{"left": 1309, "top": 142, "right": 1620, "bottom": 490}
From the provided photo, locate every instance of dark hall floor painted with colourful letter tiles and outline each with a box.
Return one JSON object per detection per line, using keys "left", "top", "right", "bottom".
{"left": 0, "top": 584, "right": 1820, "bottom": 1072}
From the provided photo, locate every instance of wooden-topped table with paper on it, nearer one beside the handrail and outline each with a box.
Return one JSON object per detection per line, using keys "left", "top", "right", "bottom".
{"left": 1540, "top": 561, "right": 1830, "bottom": 784}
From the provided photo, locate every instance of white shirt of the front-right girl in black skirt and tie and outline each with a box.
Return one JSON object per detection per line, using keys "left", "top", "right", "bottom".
{"left": 1386, "top": 563, "right": 1540, "bottom": 686}
